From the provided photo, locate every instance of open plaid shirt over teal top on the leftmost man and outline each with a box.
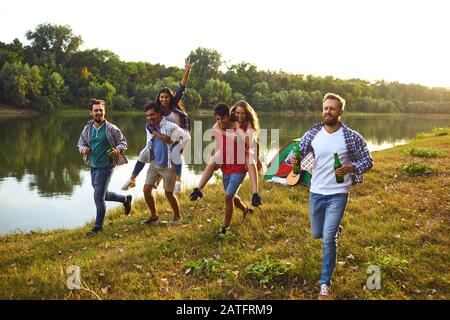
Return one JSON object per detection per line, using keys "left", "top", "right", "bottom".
{"left": 77, "top": 120, "right": 128, "bottom": 166}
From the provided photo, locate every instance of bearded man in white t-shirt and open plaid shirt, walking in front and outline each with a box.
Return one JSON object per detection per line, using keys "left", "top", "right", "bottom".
{"left": 287, "top": 93, "right": 373, "bottom": 300}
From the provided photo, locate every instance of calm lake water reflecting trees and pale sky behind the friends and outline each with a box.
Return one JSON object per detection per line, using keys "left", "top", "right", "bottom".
{"left": 0, "top": 114, "right": 450, "bottom": 234}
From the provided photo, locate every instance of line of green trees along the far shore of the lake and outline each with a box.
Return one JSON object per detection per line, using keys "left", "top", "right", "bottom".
{"left": 0, "top": 23, "right": 450, "bottom": 113}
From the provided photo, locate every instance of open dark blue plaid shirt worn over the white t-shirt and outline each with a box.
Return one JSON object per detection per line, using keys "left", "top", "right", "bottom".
{"left": 286, "top": 122, "right": 373, "bottom": 185}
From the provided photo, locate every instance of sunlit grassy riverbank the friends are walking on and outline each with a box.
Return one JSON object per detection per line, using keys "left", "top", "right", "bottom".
{"left": 0, "top": 128, "right": 450, "bottom": 299}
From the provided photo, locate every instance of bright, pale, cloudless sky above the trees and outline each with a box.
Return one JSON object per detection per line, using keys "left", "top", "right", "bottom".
{"left": 0, "top": 0, "right": 450, "bottom": 88}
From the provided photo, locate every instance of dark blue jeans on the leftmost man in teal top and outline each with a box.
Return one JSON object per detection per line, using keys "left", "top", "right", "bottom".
{"left": 91, "top": 167, "right": 125, "bottom": 228}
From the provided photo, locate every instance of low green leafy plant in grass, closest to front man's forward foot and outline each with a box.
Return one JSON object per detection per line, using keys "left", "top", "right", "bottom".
{"left": 245, "top": 255, "right": 295, "bottom": 284}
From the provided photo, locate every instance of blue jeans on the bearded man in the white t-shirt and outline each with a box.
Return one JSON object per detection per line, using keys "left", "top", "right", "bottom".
{"left": 309, "top": 192, "right": 348, "bottom": 285}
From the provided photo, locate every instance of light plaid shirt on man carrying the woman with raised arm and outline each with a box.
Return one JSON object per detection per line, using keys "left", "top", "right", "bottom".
{"left": 138, "top": 117, "right": 191, "bottom": 168}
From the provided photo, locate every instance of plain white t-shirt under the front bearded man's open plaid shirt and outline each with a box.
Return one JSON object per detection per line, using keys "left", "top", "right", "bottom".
{"left": 310, "top": 127, "right": 352, "bottom": 195}
